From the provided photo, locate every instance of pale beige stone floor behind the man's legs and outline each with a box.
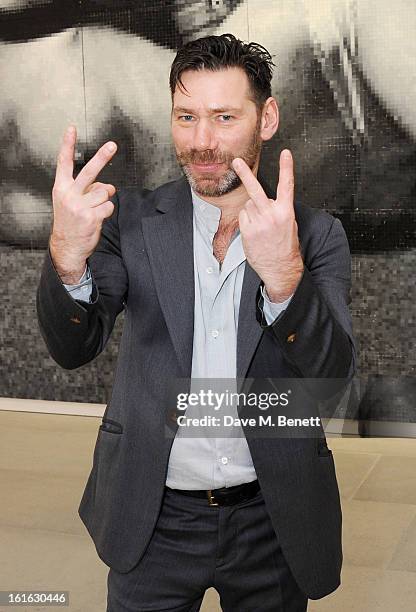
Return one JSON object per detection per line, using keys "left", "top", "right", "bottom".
{"left": 0, "top": 402, "right": 416, "bottom": 612}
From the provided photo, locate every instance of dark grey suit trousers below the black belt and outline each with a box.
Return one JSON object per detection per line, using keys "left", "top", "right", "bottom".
{"left": 107, "top": 489, "right": 308, "bottom": 612}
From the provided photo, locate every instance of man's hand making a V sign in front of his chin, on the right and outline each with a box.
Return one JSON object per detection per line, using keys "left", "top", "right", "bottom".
{"left": 232, "top": 149, "right": 303, "bottom": 302}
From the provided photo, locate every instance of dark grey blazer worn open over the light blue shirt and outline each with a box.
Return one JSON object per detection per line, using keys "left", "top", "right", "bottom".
{"left": 36, "top": 178, "right": 356, "bottom": 599}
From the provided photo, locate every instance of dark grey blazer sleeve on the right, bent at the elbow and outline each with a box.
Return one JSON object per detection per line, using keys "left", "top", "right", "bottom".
{"left": 258, "top": 217, "right": 357, "bottom": 396}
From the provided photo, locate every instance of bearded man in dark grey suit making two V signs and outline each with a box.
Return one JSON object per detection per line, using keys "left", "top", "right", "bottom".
{"left": 37, "top": 34, "right": 355, "bottom": 612}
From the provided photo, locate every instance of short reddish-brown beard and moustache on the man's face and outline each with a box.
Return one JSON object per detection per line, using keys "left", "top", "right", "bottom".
{"left": 176, "top": 117, "right": 262, "bottom": 198}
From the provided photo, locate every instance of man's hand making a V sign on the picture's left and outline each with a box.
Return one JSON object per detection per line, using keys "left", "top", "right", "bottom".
{"left": 49, "top": 126, "right": 117, "bottom": 284}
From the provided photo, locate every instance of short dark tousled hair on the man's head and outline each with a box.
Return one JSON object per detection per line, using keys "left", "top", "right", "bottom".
{"left": 169, "top": 34, "right": 275, "bottom": 110}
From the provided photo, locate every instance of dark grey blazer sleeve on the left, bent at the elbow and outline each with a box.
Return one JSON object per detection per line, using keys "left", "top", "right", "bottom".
{"left": 36, "top": 193, "right": 128, "bottom": 370}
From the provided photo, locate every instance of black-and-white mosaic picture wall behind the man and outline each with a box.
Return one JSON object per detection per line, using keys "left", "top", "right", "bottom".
{"left": 0, "top": 0, "right": 416, "bottom": 431}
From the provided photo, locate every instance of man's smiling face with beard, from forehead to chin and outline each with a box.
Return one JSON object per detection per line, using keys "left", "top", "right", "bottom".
{"left": 171, "top": 68, "right": 262, "bottom": 197}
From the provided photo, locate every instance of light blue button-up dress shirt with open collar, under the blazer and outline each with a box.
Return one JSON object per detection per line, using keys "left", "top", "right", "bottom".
{"left": 64, "top": 191, "right": 292, "bottom": 490}
